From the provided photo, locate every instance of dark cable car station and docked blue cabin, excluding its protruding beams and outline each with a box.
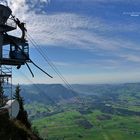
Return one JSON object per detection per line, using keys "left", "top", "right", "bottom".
{"left": 0, "top": 4, "right": 30, "bottom": 68}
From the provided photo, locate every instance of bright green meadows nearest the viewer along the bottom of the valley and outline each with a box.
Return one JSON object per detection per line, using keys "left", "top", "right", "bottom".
{"left": 33, "top": 111, "right": 140, "bottom": 140}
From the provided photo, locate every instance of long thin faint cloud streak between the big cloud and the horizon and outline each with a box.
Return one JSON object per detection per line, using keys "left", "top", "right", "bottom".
{"left": 53, "top": 59, "right": 121, "bottom": 74}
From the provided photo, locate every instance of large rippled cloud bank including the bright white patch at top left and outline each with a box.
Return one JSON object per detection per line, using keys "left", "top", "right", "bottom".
{"left": 1, "top": 0, "right": 140, "bottom": 51}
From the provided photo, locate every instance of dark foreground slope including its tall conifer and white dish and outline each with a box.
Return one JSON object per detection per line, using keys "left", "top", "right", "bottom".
{"left": 0, "top": 85, "right": 42, "bottom": 140}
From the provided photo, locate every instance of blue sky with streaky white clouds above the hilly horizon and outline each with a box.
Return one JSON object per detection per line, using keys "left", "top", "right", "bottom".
{"left": 1, "top": 0, "right": 140, "bottom": 84}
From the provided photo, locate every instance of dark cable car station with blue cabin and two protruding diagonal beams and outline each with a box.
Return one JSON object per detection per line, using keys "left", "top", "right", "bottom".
{"left": 0, "top": 4, "right": 53, "bottom": 116}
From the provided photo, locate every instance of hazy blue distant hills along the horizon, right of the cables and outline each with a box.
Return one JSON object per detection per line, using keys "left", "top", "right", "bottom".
{"left": 72, "top": 83, "right": 140, "bottom": 95}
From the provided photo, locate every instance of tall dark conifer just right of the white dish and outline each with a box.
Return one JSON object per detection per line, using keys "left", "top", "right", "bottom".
{"left": 14, "top": 84, "right": 31, "bottom": 128}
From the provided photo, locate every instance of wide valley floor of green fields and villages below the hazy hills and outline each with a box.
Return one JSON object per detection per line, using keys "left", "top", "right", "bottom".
{"left": 23, "top": 83, "right": 140, "bottom": 140}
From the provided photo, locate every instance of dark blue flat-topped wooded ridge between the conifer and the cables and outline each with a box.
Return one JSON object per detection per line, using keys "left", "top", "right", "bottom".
{"left": 21, "top": 84, "right": 78, "bottom": 104}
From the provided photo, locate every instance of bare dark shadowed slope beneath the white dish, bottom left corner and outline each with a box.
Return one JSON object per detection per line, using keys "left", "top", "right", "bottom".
{"left": 0, "top": 110, "right": 42, "bottom": 140}
